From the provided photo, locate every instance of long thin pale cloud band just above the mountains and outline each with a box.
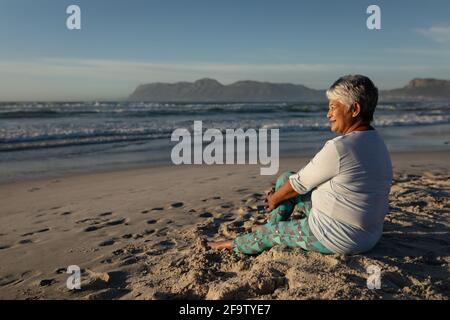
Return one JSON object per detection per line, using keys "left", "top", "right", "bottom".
{"left": 0, "top": 58, "right": 442, "bottom": 85}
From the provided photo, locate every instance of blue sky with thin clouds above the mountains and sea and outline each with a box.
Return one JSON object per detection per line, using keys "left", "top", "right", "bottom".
{"left": 0, "top": 0, "right": 450, "bottom": 101}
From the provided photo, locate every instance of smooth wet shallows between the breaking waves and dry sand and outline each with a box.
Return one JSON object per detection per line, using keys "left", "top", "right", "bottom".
{"left": 0, "top": 124, "right": 450, "bottom": 185}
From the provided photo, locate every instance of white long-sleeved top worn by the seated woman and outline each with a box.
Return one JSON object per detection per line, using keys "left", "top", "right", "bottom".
{"left": 289, "top": 130, "right": 392, "bottom": 254}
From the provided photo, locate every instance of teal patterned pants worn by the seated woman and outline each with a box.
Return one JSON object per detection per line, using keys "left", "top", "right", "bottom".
{"left": 233, "top": 172, "right": 332, "bottom": 254}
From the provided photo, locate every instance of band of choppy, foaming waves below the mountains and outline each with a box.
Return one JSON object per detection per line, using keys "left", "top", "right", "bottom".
{"left": 0, "top": 102, "right": 450, "bottom": 151}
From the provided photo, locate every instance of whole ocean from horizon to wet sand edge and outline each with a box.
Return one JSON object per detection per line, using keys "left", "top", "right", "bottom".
{"left": 0, "top": 102, "right": 450, "bottom": 183}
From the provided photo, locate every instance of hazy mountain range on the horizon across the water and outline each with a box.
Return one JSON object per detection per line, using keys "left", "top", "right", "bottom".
{"left": 128, "top": 78, "right": 450, "bottom": 102}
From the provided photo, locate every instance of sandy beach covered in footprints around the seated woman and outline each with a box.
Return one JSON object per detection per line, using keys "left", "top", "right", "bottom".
{"left": 0, "top": 151, "right": 450, "bottom": 299}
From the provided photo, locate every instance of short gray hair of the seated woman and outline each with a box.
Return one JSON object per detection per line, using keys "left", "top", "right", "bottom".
{"left": 327, "top": 74, "right": 378, "bottom": 122}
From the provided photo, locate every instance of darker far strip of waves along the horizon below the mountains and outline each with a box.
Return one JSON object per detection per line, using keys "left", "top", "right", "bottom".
{"left": 0, "top": 102, "right": 450, "bottom": 120}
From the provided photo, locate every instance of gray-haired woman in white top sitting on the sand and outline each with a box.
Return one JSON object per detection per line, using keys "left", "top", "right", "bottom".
{"left": 208, "top": 75, "right": 392, "bottom": 254}
